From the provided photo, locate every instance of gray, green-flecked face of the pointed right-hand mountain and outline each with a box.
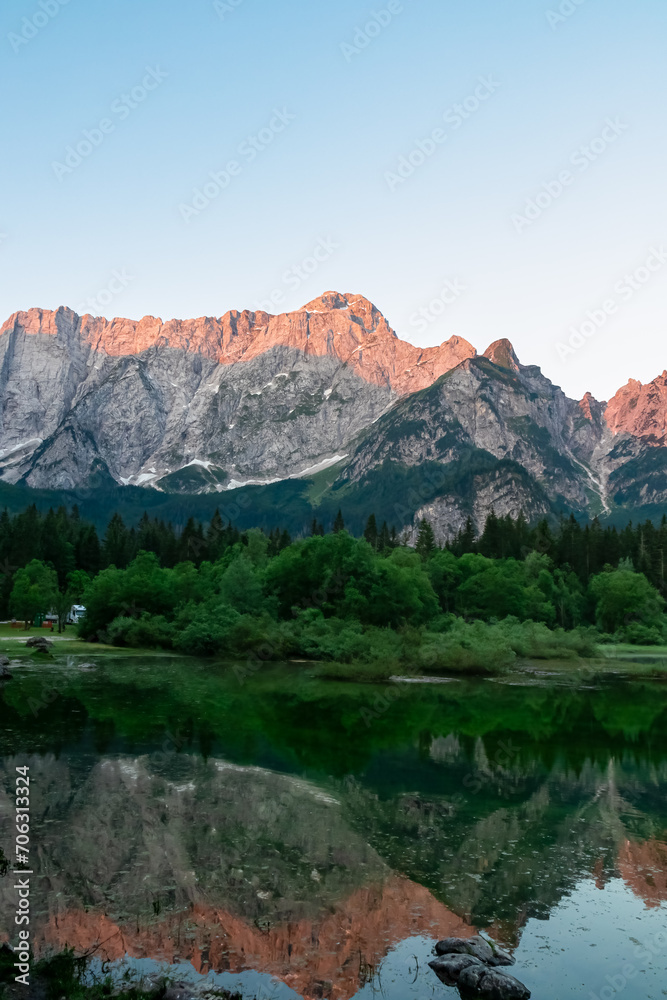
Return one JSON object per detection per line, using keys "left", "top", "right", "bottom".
{"left": 344, "top": 357, "right": 636, "bottom": 541}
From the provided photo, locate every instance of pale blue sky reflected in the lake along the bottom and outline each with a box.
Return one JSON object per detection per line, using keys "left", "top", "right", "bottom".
{"left": 94, "top": 879, "right": 667, "bottom": 1000}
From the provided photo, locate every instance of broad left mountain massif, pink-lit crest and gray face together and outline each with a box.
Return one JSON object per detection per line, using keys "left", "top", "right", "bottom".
{"left": 0, "top": 292, "right": 475, "bottom": 492}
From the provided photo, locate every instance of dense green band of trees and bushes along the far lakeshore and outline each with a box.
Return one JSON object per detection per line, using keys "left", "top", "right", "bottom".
{"left": 0, "top": 506, "right": 667, "bottom": 670}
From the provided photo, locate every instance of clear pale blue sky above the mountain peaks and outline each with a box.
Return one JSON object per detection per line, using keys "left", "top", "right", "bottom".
{"left": 0, "top": 0, "right": 667, "bottom": 398}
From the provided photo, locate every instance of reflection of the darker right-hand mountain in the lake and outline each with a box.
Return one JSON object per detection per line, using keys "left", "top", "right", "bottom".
{"left": 348, "top": 741, "right": 667, "bottom": 928}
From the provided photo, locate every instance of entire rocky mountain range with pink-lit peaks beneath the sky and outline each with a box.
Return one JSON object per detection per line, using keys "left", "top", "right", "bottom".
{"left": 0, "top": 292, "right": 667, "bottom": 539}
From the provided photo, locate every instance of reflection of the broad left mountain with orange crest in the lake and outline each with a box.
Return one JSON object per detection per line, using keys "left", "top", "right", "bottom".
{"left": 0, "top": 756, "right": 472, "bottom": 997}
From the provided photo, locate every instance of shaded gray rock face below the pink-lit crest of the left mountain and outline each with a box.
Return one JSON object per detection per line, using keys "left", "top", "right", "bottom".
{"left": 0, "top": 310, "right": 396, "bottom": 492}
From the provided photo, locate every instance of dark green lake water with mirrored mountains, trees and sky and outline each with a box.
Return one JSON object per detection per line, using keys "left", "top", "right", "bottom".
{"left": 0, "top": 656, "right": 667, "bottom": 1000}
